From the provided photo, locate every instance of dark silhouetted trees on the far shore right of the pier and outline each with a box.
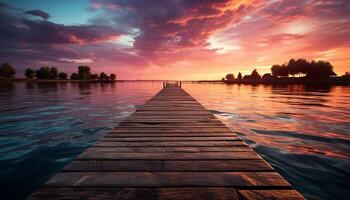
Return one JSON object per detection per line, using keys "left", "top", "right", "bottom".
{"left": 222, "top": 58, "right": 350, "bottom": 81}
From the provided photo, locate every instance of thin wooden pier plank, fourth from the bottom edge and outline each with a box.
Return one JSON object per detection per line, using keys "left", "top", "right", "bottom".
{"left": 77, "top": 151, "right": 261, "bottom": 160}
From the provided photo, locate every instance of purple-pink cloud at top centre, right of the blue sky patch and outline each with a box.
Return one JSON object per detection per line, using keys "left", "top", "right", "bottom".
{"left": 93, "top": 0, "right": 253, "bottom": 56}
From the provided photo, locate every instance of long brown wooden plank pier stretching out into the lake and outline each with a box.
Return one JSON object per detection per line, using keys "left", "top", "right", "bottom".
{"left": 29, "top": 84, "right": 304, "bottom": 200}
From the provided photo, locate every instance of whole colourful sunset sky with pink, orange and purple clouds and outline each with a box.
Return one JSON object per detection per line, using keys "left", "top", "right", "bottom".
{"left": 0, "top": 0, "right": 350, "bottom": 80}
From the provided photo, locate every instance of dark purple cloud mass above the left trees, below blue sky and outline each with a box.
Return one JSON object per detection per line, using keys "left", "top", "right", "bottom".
{"left": 0, "top": 2, "right": 123, "bottom": 71}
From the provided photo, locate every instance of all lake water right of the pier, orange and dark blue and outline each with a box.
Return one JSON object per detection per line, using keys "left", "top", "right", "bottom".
{"left": 184, "top": 84, "right": 350, "bottom": 199}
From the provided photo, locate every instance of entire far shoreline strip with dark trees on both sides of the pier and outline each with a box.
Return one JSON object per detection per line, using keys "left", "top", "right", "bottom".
{"left": 0, "top": 58, "right": 350, "bottom": 85}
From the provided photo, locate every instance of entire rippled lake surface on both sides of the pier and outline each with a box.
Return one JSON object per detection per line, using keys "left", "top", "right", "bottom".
{"left": 0, "top": 82, "right": 350, "bottom": 199}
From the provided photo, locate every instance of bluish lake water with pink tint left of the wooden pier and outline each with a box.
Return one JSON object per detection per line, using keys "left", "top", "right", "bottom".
{"left": 0, "top": 82, "right": 162, "bottom": 199}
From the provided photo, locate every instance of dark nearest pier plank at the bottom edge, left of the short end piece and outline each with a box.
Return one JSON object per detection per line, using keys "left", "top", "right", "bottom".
{"left": 28, "top": 187, "right": 238, "bottom": 200}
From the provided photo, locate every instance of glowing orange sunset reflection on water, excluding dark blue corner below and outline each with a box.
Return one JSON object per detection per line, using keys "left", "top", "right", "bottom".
{"left": 185, "top": 84, "right": 350, "bottom": 159}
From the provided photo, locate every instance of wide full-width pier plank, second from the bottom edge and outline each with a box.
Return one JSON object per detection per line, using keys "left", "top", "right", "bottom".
{"left": 45, "top": 172, "right": 290, "bottom": 188}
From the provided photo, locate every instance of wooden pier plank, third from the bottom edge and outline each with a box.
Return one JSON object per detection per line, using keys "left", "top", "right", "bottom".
{"left": 63, "top": 159, "right": 273, "bottom": 172}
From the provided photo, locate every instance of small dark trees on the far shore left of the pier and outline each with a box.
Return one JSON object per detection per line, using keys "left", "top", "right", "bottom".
{"left": 0, "top": 63, "right": 117, "bottom": 81}
